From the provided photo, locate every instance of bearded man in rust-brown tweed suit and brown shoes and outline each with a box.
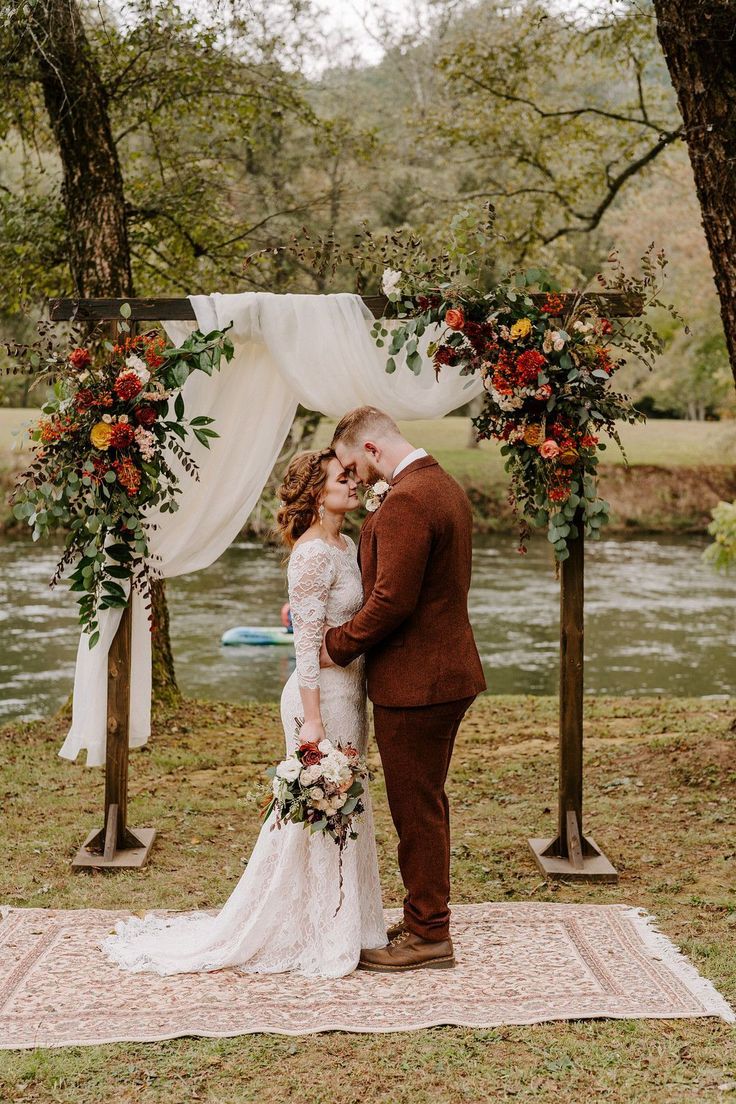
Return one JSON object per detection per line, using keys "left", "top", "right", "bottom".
{"left": 321, "top": 406, "right": 486, "bottom": 972}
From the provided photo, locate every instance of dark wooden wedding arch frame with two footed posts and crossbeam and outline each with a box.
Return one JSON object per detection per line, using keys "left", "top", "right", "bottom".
{"left": 49, "top": 291, "right": 642, "bottom": 882}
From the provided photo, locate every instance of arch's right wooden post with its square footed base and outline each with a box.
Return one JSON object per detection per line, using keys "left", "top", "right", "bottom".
{"left": 529, "top": 510, "right": 618, "bottom": 882}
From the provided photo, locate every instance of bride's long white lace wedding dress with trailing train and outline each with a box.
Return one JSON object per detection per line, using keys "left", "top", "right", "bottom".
{"left": 100, "top": 538, "right": 386, "bottom": 977}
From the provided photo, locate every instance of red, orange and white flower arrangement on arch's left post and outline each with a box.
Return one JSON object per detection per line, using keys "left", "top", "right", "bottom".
{"left": 8, "top": 304, "right": 233, "bottom": 647}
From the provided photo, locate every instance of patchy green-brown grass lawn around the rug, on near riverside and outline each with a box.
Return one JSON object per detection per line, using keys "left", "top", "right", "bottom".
{"left": 0, "top": 696, "right": 736, "bottom": 1104}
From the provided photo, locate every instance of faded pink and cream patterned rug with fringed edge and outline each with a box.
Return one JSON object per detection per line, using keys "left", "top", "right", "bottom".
{"left": 0, "top": 903, "right": 736, "bottom": 1049}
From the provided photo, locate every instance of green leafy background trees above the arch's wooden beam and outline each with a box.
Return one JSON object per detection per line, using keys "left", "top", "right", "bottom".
{"left": 0, "top": 0, "right": 733, "bottom": 417}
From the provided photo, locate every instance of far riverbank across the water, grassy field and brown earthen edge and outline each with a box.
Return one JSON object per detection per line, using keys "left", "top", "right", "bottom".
{"left": 0, "top": 410, "right": 736, "bottom": 539}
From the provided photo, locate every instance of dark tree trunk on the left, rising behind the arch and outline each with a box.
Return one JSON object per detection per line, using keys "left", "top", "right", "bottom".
{"left": 28, "top": 0, "right": 179, "bottom": 701}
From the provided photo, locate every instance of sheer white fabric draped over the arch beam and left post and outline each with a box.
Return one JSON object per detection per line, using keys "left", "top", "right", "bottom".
{"left": 60, "top": 291, "right": 482, "bottom": 766}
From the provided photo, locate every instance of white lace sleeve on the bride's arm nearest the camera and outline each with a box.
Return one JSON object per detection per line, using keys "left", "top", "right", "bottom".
{"left": 287, "top": 541, "right": 334, "bottom": 690}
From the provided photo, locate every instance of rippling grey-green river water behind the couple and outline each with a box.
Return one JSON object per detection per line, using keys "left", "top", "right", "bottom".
{"left": 0, "top": 535, "right": 736, "bottom": 720}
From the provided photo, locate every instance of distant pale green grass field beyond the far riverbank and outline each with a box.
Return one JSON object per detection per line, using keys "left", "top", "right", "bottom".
{"left": 0, "top": 408, "right": 736, "bottom": 482}
